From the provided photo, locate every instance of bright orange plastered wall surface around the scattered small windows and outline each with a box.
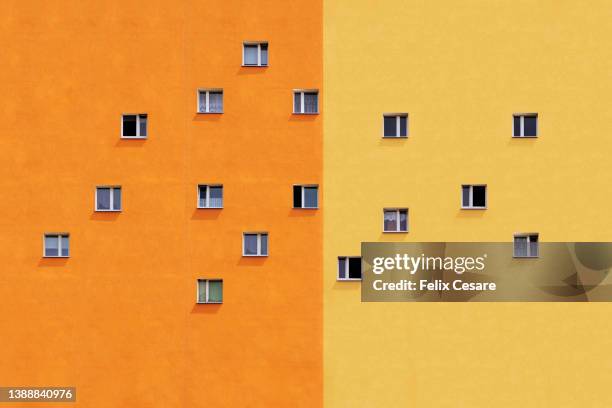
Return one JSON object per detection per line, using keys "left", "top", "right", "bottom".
{"left": 0, "top": 0, "right": 322, "bottom": 407}
